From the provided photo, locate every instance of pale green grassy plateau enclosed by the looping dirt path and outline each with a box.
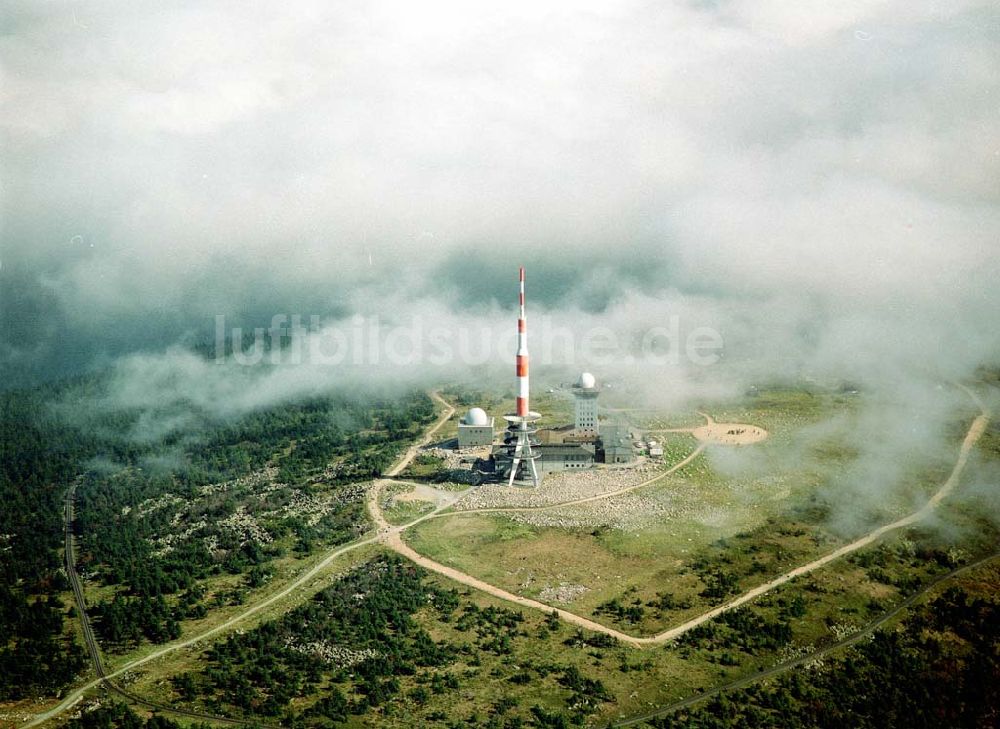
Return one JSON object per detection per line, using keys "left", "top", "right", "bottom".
{"left": 407, "top": 390, "right": 980, "bottom": 634}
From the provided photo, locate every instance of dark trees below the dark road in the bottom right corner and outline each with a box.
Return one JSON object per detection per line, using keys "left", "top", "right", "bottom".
{"left": 651, "top": 588, "right": 1000, "bottom": 729}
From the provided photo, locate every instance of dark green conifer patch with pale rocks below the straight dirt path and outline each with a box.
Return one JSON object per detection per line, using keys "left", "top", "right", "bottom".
{"left": 181, "top": 556, "right": 459, "bottom": 724}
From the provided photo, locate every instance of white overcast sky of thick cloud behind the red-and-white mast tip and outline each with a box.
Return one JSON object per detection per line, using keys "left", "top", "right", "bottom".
{"left": 0, "top": 0, "right": 1000, "bottom": 385}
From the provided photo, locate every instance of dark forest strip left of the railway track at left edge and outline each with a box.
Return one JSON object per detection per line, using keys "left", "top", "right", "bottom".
{"left": 0, "top": 389, "right": 88, "bottom": 699}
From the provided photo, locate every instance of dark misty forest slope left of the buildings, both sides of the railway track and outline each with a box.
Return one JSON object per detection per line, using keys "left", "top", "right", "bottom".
{"left": 0, "top": 374, "right": 434, "bottom": 700}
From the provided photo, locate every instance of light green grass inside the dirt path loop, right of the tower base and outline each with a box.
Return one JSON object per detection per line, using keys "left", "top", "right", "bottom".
{"left": 406, "top": 391, "right": 852, "bottom": 633}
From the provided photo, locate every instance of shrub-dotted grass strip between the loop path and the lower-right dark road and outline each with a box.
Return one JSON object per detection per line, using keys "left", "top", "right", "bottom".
{"left": 111, "top": 500, "right": 1000, "bottom": 727}
